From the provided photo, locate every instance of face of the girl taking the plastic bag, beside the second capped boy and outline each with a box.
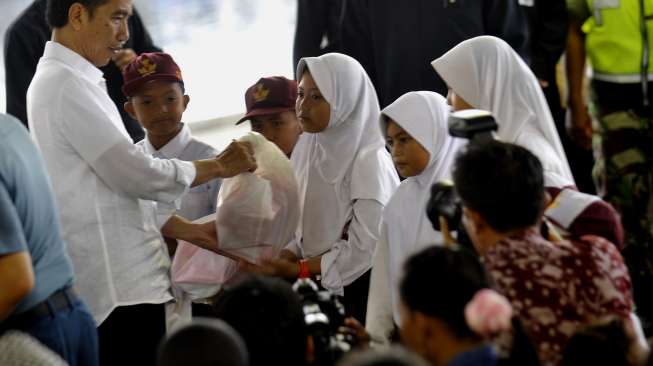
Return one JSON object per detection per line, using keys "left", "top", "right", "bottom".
{"left": 295, "top": 71, "right": 331, "bottom": 133}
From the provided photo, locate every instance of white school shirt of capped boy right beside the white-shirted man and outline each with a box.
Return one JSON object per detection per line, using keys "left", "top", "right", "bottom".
{"left": 136, "top": 124, "right": 222, "bottom": 224}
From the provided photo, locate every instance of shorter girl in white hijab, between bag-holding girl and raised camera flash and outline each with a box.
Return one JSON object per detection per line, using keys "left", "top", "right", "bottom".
{"left": 367, "top": 91, "right": 465, "bottom": 341}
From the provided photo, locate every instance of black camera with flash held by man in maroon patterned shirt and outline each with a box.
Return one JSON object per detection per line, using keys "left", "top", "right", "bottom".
{"left": 426, "top": 109, "right": 499, "bottom": 246}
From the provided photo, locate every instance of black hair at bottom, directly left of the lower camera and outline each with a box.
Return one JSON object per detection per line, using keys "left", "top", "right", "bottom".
{"left": 214, "top": 275, "right": 308, "bottom": 366}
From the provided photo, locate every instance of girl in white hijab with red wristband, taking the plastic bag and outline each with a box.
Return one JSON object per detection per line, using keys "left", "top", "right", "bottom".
{"left": 264, "top": 53, "right": 399, "bottom": 321}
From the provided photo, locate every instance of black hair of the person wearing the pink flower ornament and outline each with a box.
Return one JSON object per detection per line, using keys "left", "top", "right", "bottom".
{"left": 399, "top": 246, "right": 490, "bottom": 338}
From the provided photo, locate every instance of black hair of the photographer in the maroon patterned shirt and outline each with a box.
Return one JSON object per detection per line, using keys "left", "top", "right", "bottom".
{"left": 453, "top": 141, "right": 544, "bottom": 232}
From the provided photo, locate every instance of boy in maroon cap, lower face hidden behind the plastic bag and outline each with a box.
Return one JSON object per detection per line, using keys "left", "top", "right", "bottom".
{"left": 236, "top": 76, "right": 302, "bottom": 157}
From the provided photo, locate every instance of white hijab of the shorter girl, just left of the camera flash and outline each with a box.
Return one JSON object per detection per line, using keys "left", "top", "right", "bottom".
{"left": 381, "top": 91, "right": 466, "bottom": 321}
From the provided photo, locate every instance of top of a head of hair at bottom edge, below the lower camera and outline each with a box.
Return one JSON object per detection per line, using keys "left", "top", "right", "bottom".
{"left": 337, "top": 346, "right": 428, "bottom": 366}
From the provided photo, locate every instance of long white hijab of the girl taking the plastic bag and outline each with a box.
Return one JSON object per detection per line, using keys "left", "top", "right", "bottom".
{"left": 291, "top": 53, "right": 398, "bottom": 257}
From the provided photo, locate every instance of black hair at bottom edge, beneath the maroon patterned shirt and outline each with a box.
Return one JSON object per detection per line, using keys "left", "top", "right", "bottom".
{"left": 562, "top": 319, "right": 630, "bottom": 366}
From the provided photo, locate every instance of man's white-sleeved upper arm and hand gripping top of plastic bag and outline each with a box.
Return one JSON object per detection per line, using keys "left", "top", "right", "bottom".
{"left": 52, "top": 79, "right": 256, "bottom": 203}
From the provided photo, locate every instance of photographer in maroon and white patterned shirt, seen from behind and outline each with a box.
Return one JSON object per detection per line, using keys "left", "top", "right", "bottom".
{"left": 454, "top": 141, "right": 633, "bottom": 364}
